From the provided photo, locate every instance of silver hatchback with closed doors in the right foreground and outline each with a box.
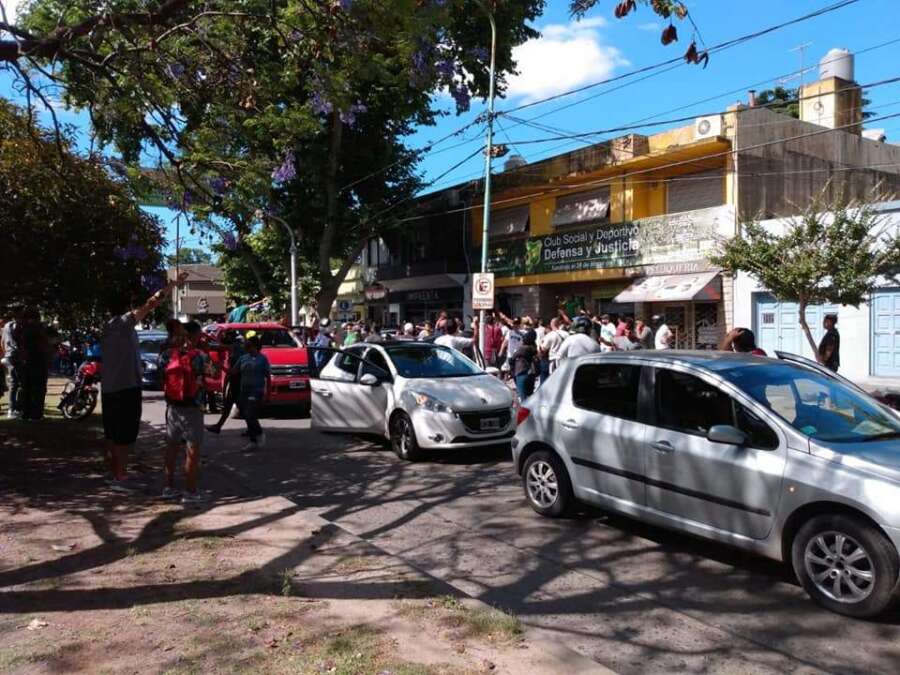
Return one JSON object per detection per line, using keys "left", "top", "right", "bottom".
{"left": 513, "top": 351, "right": 900, "bottom": 617}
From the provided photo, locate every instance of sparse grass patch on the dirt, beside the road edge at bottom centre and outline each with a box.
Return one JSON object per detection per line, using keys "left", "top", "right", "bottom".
{"left": 399, "top": 596, "right": 525, "bottom": 642}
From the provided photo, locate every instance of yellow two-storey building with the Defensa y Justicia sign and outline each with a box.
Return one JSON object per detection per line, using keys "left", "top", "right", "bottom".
{"left": 471, "top": 114, "right": 736, "bottom": 348}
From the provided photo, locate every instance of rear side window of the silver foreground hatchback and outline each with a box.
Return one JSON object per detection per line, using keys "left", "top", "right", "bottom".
{"left": 572, "top": 363, "right": 641, "bottom": 420}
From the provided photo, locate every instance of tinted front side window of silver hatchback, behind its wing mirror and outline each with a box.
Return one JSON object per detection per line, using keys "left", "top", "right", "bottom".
{"left": 656, "top": 368, "right": 778, "bottom": 450}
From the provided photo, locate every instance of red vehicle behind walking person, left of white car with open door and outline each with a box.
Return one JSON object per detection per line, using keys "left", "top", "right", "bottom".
{"left": 203, "top": 322, "right": 310, "bottom": 411}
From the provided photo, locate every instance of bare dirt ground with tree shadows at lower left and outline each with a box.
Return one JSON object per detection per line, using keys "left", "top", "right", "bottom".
{"left": 0, "top": 383, "right": 604, "bottom": 675}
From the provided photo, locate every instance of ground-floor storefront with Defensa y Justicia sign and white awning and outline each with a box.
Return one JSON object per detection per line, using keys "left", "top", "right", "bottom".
{"left": 489, "top": 203, "right": 734, "bottom": 340}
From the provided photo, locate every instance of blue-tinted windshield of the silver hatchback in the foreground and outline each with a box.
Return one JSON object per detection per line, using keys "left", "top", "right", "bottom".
{"left": 722, "top": 363, "right": 900, "bottom": 443}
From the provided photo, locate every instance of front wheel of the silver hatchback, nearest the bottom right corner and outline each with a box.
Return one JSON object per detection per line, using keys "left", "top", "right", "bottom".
{"left": 791, "top": 514, "right": 900, "bottom": 618}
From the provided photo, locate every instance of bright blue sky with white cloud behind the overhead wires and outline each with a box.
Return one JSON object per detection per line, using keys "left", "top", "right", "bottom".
{"left": 0, "top": 0, "right": 900, "bottom": 254}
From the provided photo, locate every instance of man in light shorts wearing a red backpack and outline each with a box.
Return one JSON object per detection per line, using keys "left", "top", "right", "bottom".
{"left": 160, "top": 321, "right": 209, "bottom": 504}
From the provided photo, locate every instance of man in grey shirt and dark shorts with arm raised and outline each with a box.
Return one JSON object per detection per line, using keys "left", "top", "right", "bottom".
{"left": 100, "top": 272, "right": 187, "bottom": 492}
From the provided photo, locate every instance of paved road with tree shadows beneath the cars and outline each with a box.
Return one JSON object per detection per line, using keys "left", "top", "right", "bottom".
{"left": 145, "top": 394, "right": 900, "bottom": 674}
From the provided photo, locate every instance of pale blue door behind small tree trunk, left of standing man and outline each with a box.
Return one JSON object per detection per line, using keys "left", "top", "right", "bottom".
{"left": 753, "top": 293, "right": 838, "bottom": 358}
